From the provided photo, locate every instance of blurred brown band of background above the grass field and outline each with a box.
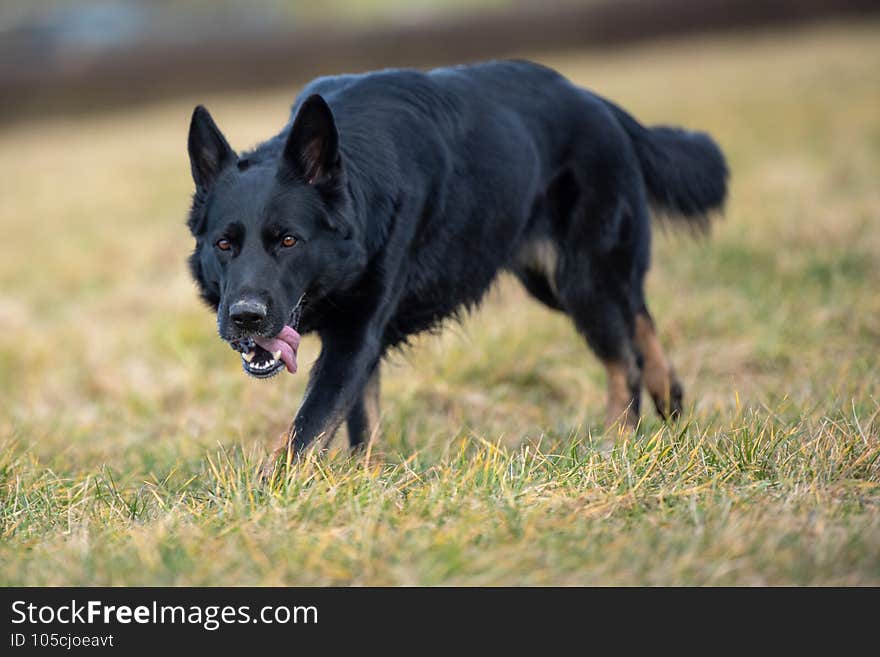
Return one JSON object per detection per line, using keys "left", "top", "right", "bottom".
{"left": 0, "top": 0, "right": 880, "bottom": 122}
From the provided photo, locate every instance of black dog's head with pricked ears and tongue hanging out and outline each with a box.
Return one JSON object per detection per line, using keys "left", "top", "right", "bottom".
{"left": 188, "top": 95, "right": 365, "bottom": 378}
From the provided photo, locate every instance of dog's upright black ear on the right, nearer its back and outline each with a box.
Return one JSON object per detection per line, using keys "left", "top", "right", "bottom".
{"left": 283, "top": 94, "right": 342, "bottom": 186}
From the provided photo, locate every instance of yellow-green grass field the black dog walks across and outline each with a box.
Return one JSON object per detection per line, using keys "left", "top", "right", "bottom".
{"left": 0, "top": 22, "right": 880, "bottom": 585}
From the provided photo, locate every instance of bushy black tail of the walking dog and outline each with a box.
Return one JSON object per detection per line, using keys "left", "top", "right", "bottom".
{"left": 606, "top": 101, "right": 729, "bottom": 231}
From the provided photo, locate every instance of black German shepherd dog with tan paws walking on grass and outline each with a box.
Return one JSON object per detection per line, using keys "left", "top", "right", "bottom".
{"left": 188, "top": 61, "right": 728, "bottom": 462}
